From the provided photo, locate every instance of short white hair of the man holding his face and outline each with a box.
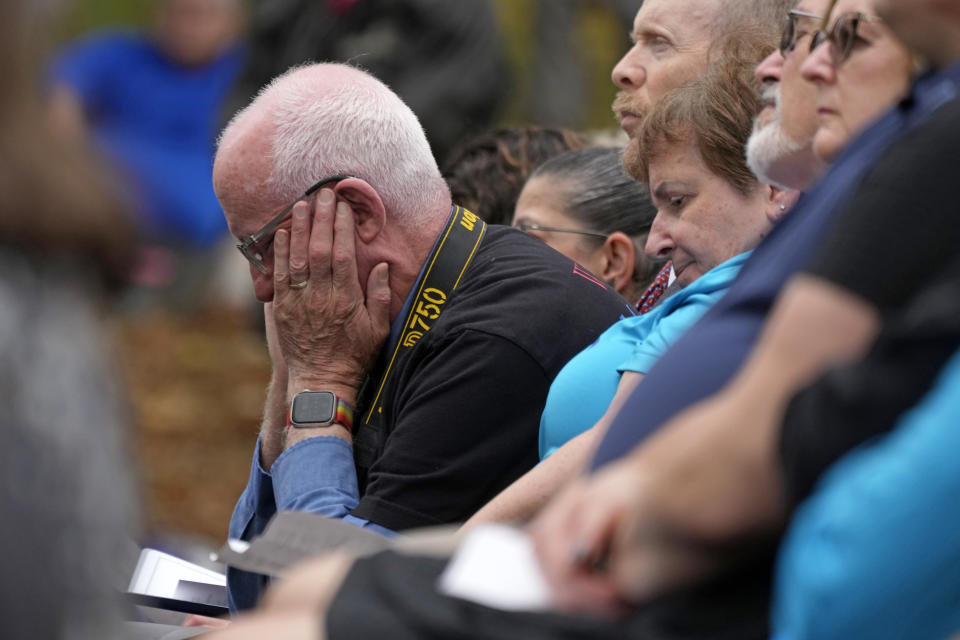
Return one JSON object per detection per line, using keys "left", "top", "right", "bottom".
{"left": 221, "top": 64, "right": 450, "bottom": 227}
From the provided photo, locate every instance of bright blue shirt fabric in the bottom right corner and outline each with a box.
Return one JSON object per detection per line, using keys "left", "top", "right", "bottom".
{"left": 773, "top": 355, "right": 960, "bottom": 640}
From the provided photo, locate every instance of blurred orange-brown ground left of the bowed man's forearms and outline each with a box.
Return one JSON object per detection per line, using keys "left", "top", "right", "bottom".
{"left": 117, "top": 312, "right": 270, "bottom": 546}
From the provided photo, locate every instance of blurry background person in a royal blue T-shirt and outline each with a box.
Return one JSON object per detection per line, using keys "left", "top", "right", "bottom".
{"left": 50, "top": 0, "right": 243, "bottom": 303}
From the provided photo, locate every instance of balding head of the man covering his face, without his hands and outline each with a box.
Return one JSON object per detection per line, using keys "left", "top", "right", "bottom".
{"left": 213, "top": 64, "right": 450, "bottom": 304}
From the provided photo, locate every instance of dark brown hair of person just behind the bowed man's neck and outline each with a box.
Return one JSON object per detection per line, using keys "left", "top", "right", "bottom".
{"left": 443, "top": 126, "right": 587, "bottom": 224}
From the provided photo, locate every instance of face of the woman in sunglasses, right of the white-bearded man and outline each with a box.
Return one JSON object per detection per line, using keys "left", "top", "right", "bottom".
{"left": 802, "top": 0, "right": 915, "bottom": 163}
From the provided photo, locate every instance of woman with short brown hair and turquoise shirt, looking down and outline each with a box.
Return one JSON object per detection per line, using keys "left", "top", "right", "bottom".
{"left": 468, "top": 36, "right": 795, "bottom": 526}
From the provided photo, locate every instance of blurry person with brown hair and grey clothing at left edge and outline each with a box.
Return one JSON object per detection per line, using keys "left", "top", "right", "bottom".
{"left": 0, "top": 0, "right": 142, "bottom": 639}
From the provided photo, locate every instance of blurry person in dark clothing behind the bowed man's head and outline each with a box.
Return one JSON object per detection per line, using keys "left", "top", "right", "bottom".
{"left": 226, "top": 0, "right": 508, "bottom": 164}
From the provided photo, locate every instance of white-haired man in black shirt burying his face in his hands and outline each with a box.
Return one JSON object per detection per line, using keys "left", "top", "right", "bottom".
{"left": 214, "top": 64, "right": 630, "bottom": 608}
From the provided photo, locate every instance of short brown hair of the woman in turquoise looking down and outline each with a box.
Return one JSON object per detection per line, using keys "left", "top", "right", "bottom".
{"left": 628, "top": 30, "right": 770, "bottom": 194}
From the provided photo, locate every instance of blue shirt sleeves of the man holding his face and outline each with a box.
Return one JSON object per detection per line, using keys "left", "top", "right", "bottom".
{"left": 227, "top": 436, "right": 396, "bottom": 611}
